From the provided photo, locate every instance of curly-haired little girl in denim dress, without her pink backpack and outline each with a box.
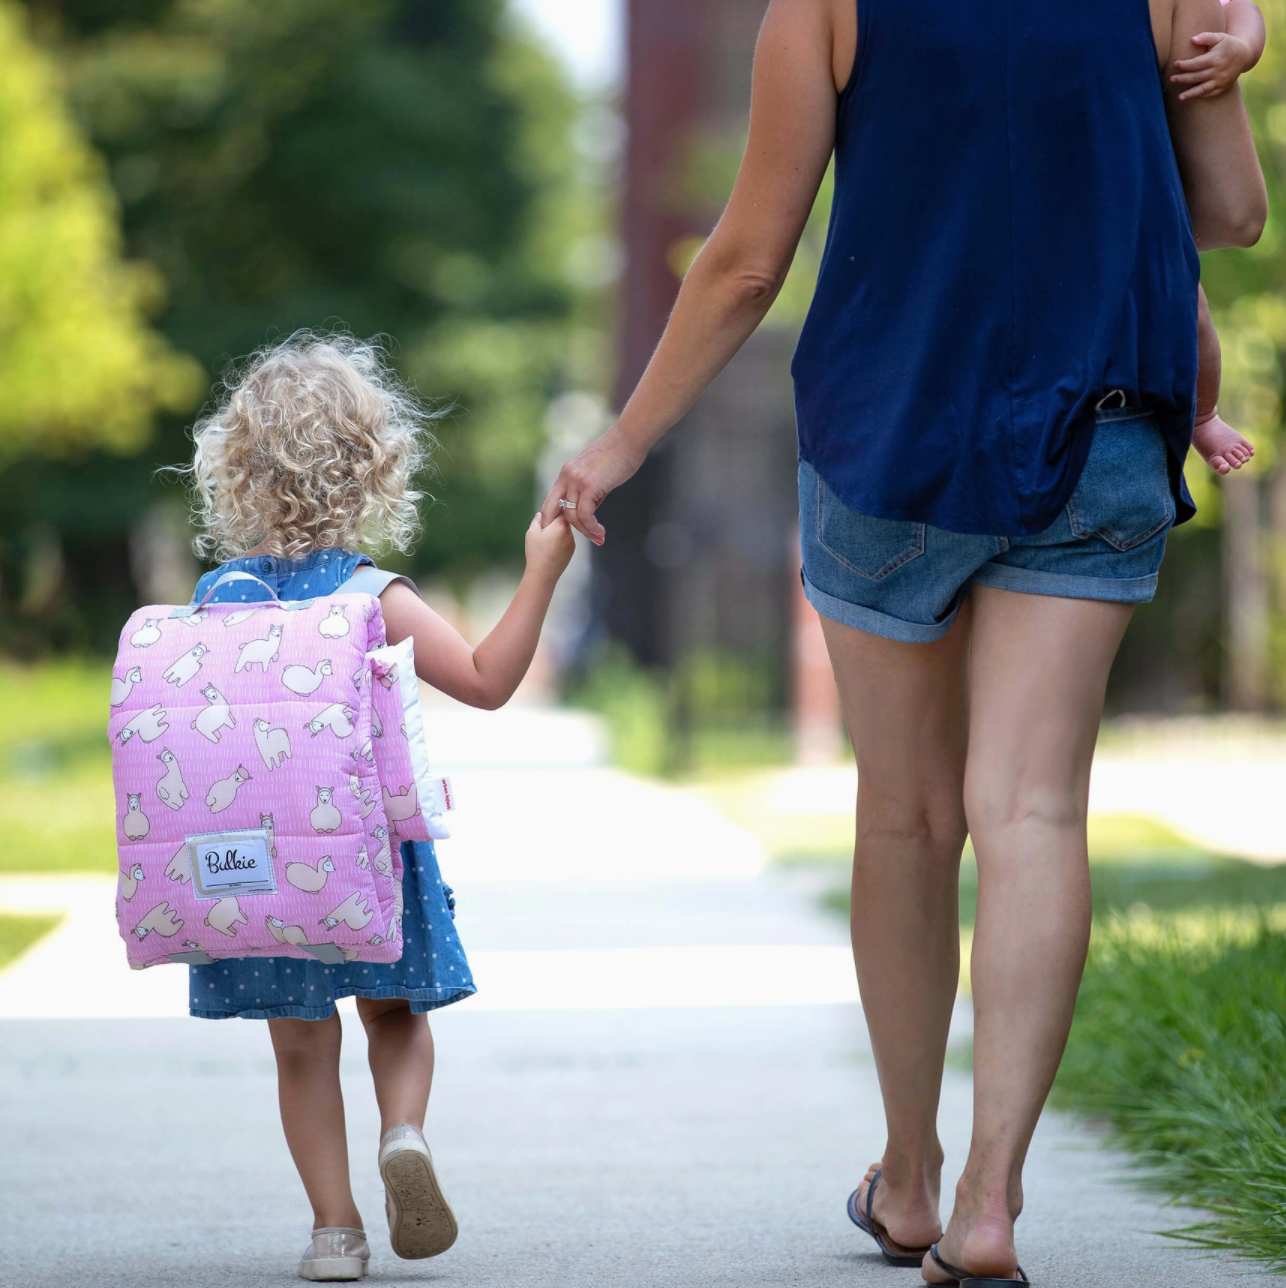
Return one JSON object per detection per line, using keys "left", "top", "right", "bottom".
{"left": 175, "top": 332, "right": 573, "bottom": 1280}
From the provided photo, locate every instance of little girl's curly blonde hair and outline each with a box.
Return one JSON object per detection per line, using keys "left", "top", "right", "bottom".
{"left": 182, "top": 331, "right": 439, "bottom": 559}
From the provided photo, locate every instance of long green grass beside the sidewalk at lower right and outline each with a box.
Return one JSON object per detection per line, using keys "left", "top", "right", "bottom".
{"left": 1055, "top": 913, "right": 1286, "bottom": 1271}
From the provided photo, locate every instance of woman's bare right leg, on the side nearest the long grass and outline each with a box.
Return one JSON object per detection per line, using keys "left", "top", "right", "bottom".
{"left": 925, "top": 586, "right": 1131, "bottom": 1282}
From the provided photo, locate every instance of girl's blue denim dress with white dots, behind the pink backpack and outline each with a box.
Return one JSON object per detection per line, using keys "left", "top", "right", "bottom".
{"left": 188, "top": 550, "right": 477, "bottom": 1020}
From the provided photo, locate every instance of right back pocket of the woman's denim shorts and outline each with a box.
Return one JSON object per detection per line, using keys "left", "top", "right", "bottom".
{"left": 1067, "top": 415, "right": 1174, "bottom": 550}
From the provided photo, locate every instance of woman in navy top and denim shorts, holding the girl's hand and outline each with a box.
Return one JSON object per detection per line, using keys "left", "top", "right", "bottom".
{"left": 542, "top": 0, "right": 1265, "bottom": 1284}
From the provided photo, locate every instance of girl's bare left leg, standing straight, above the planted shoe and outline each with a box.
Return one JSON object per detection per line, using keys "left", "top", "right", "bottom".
{"left": 268, "top": 1014, "right": 362, "bottom": 1230}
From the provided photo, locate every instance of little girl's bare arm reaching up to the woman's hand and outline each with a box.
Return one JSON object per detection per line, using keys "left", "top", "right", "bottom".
{"left": 380, "top": 514, "right": 576, "bottom": 711}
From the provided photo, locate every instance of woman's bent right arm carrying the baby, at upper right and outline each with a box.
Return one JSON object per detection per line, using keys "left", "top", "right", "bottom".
{"left": 1153, "top": 0, "right": 1268, "bottom": 250}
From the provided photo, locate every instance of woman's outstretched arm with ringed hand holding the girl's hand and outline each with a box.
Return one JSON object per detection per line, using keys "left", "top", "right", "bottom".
{"left": 541, "top": 0, "right": 852, "bottom": 545}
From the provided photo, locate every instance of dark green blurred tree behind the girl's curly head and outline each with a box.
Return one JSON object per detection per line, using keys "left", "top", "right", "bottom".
{"left": 0, "top": 0, "right": 603, "bottom": 654}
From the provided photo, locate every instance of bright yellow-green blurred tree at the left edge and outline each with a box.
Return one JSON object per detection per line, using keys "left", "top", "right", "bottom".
{"left": 0, "top": 3, "right": 201, "bottom": 464}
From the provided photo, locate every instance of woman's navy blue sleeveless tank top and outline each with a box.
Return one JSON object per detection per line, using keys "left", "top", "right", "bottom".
{"left": 792, "top": 0, "right": 1200, "bottom": 536}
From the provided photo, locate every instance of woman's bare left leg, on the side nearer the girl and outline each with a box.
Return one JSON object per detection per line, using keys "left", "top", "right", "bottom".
{"left": 822, "top": 604, "right": 969, "bottom": 1251}
